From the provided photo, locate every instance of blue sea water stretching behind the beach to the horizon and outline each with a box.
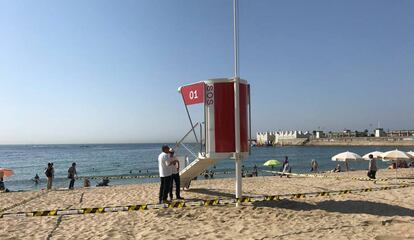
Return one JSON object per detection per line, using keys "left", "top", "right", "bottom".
{"left": 0, "top": 144, "right": 414, "bottom": 191}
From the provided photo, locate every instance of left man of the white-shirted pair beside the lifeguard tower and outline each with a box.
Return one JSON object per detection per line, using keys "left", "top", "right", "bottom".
{"left": 158, "top": 145, "right": 177, "bottom": 204}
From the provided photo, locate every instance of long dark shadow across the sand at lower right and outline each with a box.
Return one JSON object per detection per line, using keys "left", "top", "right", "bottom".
{"left": 253, "top": 200, "right": 414, "bottom": 217}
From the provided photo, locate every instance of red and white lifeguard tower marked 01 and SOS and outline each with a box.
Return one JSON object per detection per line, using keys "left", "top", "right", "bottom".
{"left": 177, "top": 78, "right": 250, "bottom": 188}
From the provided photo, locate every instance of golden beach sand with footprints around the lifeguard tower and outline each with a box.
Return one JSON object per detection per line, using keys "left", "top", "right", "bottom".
{"left": 0, "top": 169, "right": 414, "bottom": 240}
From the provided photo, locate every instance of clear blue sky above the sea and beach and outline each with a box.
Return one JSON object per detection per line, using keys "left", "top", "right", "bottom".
{"left": 0, "top": 0, "right": 414, "bottom": 144}
